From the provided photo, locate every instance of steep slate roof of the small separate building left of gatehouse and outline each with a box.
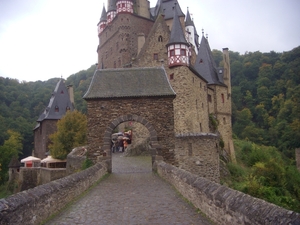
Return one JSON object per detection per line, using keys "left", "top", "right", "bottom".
{"left": 35, "top": 79, "right": 74, "bottom": 121}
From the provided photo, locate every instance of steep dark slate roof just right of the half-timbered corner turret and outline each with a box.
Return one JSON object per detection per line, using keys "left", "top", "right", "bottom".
{"left": 194, "top": 36, "right": 224, "bottom": 85}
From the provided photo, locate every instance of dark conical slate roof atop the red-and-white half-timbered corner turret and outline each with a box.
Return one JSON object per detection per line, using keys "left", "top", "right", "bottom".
{"left": 167, "top": 5, "right": 188, "bottom": 45}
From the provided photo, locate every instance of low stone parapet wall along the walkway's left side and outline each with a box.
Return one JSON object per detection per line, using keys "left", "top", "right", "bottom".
{"left": 0, "top": 162, "right": 107, "bottom": 225}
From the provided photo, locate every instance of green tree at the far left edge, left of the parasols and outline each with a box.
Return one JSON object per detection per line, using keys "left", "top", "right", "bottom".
{"left": 0, "top": 130, "right": 23, "bottom": 184}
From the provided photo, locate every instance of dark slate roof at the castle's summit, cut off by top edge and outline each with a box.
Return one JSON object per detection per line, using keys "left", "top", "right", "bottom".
{"left": 150, "top": 0, "right": 185, "bottom": 20}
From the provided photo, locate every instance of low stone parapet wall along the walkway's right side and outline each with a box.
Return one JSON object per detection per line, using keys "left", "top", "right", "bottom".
{"left": 155, "top": 161, "right": 300, "bottom": 225}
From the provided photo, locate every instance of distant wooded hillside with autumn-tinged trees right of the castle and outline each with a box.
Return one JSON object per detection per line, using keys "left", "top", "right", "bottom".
{"left": 213, "top": 46, "right": 300, "bottom": 156}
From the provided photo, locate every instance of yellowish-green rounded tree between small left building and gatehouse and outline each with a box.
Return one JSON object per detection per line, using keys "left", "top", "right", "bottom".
{"left": 49, "top": 110, "right": 87, "bottom": 159}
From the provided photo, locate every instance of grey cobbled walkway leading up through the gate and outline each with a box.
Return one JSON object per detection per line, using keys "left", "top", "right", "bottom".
{"left": 47, "top": 153, "right": 212, "bottom": 225}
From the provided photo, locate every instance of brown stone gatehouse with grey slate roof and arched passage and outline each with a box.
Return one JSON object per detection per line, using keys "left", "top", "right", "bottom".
{"left": 83, "top": 68, "right": 176, "bottom": 172}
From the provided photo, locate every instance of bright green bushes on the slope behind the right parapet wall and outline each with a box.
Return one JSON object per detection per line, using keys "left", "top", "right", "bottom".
{"left": 225, "top": 140, "right": 300, "bottom": 212}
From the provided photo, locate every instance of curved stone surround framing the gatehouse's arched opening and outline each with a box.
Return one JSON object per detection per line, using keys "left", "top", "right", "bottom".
{"left": 101, "top": 114, "right": 162, "bottom": 172}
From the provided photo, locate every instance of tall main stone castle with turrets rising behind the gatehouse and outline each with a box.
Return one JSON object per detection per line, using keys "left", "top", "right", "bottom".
{"left": 97, "top": 0, "right": 234, "bottom": 159}
